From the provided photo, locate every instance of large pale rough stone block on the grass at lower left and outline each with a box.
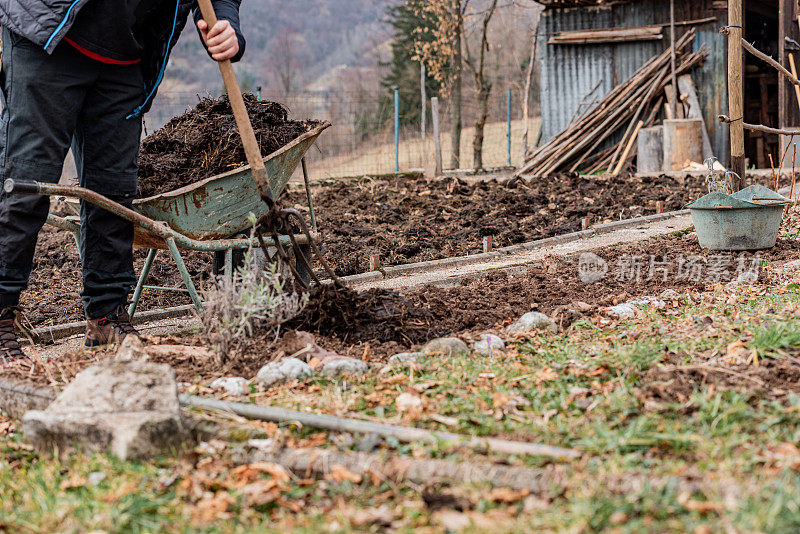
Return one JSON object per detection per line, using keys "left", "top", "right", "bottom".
{"left": 22, "top": 360, "right": 189, "bottom": 460}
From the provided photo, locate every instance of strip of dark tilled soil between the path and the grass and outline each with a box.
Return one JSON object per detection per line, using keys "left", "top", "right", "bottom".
{"left": 291, "top": 233, "right": 800, "bottom": 348}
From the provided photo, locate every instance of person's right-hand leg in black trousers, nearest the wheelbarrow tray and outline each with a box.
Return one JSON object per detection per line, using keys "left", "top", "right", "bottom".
{"left": 73, "top": 59, "right": 144, "bottom": 326}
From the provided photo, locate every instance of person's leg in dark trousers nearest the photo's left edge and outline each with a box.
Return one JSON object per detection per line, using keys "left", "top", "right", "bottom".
{"left": 0, "top": 28, "right": 94, "bottom": 310}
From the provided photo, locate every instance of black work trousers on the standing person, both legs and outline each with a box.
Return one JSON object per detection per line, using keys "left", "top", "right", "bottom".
{"left": 0, "top": 28, "right": 144, "bottom": 319}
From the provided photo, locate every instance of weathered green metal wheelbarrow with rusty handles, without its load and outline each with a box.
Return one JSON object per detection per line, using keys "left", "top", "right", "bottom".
{"left": 4, "top": 122, "right": 330, "bottom": 317}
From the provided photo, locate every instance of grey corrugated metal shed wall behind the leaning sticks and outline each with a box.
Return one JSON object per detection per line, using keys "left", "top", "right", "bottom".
{"left": 539, "top": 0, "right": 728, "bottom": 161}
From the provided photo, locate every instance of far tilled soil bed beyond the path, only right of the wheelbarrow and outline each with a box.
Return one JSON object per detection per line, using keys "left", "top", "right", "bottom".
{"left": 289, "top": 175, "right": 724, "bottom": 276}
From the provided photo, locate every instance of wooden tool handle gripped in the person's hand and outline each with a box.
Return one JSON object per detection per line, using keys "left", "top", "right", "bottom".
{"left": 197, "top": 0, "right": 275, "bottom": 207}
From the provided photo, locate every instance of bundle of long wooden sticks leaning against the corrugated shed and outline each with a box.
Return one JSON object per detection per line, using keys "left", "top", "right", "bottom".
{"left": 516, "top": 30, "right": 709, "bottom": 176}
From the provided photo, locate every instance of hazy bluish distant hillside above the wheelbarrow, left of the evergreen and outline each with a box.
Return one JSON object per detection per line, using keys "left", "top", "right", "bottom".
{"left": 165, "top": 0, "right": 399, "bottom": 92}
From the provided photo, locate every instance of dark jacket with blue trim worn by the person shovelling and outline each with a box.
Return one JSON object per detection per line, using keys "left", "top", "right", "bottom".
{"left": 0, "top": 0, "right": 245, "bottom": 117}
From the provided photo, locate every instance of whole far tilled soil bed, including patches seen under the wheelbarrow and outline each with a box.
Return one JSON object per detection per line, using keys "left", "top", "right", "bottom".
{"left": 23, "top": 174, "right": 720, "bottom": 326}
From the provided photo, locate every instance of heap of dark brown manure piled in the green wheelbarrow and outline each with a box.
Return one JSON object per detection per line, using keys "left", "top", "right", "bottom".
{"left": 139, "top": 94, "right": 319, "bottom": 198}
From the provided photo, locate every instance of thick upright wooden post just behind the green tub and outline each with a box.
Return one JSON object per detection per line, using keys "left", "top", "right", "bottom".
{"left": 728, "top": 0, "right": 745, "bottom": 192}
